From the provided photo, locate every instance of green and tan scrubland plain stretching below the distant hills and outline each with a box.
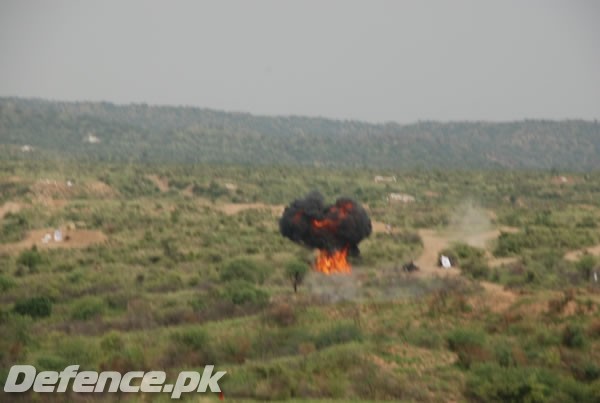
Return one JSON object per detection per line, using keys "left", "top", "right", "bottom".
{"left": 0, "top": 157, "right": 600, "bottom": 402}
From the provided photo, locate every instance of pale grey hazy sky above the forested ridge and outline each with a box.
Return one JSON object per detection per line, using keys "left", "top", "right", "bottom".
{"left": 0, "top": 0, "right": 600, "bottom": 123}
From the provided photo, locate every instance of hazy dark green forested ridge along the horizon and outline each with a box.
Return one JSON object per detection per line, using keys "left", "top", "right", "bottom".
{"left": 0, "top": 98, "right": 600, "bottom": 171}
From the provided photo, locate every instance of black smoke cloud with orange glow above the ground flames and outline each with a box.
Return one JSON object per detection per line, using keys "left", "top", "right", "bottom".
{"left": 279, "top": 192, "right": 371, "bottom": 256}
